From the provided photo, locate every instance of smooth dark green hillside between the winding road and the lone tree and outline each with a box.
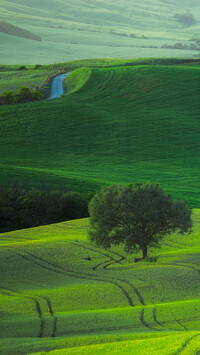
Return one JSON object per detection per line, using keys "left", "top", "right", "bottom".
{"left": 0, "top": 62, "right": 200, "bottom": 207}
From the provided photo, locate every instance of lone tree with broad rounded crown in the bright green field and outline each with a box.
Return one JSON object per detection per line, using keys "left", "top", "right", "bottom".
{"left": 89, "top": 184, "right": 192, "bottom": 259}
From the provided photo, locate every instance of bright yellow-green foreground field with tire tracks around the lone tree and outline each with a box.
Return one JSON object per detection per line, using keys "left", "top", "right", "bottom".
{"left": 0, "top": 210, "right": 200, "bottom": 355}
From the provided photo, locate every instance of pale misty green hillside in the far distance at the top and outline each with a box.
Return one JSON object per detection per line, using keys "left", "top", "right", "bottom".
{"left": 0, "top": 0, "right": 200, "bottom": 64}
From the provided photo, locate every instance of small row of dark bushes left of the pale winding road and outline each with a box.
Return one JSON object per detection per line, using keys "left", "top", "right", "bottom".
{"left": 0, "top": 86, "right": 45, "bottom": 105}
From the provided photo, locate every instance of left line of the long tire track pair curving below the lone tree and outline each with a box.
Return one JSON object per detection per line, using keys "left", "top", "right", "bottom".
{"left": 6, "top": 247, "right": 134, "bottom": 307}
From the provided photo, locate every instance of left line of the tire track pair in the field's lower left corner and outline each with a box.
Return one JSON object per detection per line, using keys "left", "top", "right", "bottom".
{"left": 0, "top": 286, "right": 45, "bottom": 338}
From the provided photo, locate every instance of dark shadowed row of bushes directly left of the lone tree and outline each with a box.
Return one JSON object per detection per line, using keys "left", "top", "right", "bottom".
{"left": 0, "top": 184, "right": 93, "bottom": 233}
